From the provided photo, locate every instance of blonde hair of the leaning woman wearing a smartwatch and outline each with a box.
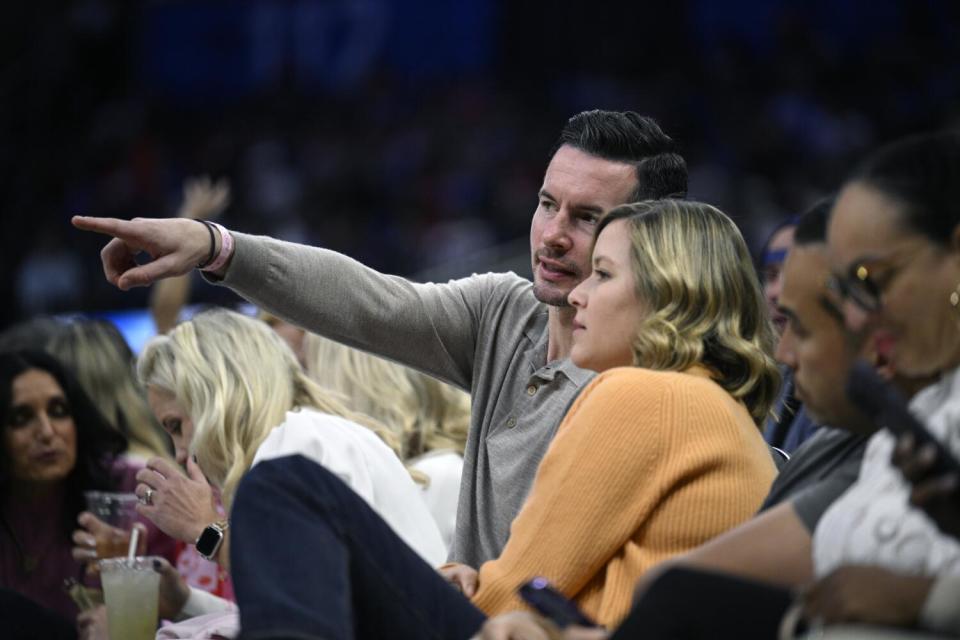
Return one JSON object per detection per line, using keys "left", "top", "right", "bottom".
{"left": 137, "top": 309, "right": 401, "bottom": 507}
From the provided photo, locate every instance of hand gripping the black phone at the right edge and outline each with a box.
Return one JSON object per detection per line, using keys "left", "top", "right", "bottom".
{"left": 891, "top": 434, "right": 960, "bottom": 538}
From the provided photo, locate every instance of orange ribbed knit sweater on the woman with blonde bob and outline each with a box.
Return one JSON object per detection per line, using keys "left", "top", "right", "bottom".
{"left": 473, "top": 367, "right": 776, "bottom": 627}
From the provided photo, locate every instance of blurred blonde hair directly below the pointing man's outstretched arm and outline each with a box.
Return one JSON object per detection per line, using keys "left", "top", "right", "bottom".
{"left": 303, "top": 333, "right": 470, "bottom": 459}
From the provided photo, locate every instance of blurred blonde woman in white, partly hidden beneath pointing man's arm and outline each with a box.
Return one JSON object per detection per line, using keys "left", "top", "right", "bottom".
{"left": 303, "top": 333, "right": 470, "bottom": 548}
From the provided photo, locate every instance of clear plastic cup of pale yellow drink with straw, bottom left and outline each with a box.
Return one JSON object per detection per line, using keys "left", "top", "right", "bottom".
{"left": 100, "top": 556, "right": 160, "bottom": 640}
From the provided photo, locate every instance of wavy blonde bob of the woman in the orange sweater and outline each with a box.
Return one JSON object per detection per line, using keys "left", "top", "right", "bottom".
{"left": 596, "top": 200, "right": 780, "bottom": 425}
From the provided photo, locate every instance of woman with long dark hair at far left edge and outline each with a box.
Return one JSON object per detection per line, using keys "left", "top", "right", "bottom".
{"left": 0, "top": 351, "right": 172, "bottom": 621}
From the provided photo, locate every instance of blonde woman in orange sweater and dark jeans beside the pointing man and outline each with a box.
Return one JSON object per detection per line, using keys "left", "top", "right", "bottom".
{"left": 227, "top": 200, "right": 779, "bottom": 638}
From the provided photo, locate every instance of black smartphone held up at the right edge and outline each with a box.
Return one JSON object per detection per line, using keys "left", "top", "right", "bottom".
{"left": 847, "top": 360, "right": 960, "bottom": 476}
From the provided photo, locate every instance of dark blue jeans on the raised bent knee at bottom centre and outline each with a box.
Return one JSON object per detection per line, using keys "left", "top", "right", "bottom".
{"left": 230, "top": 455, "right": 485, "bottom": 640}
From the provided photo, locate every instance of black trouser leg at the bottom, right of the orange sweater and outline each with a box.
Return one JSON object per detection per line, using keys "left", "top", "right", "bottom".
{"left": 610, "top": 568, "right": 793, "bottom": 640}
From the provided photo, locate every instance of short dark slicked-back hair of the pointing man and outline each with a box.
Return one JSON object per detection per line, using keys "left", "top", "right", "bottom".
{"left": 550, "top": 109, "right": 687, "bottom": 202}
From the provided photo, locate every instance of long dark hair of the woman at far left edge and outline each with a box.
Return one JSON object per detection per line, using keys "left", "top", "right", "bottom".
{"left": 0, "top": 351, "right": 127, "bottom": 536}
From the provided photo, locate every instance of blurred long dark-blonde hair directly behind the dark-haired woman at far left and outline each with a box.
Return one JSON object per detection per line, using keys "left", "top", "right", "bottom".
{"left": 46, "top": 320, "right": 171, "bottom": 458}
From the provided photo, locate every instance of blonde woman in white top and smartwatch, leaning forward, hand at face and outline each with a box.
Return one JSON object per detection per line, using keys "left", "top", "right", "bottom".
{"left": 128, "top": 310, "right": 445, "bottom": 614}
